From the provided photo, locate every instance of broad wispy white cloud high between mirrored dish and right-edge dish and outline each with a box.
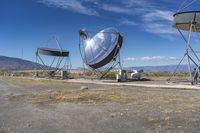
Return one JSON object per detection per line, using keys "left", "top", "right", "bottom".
{"left": 101, "top": 0, "right": 177, "bottom": 40}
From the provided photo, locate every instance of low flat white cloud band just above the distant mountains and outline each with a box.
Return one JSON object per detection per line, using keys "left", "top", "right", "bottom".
{"left": 125, "top": 56, "right": 178, "bottom": 61}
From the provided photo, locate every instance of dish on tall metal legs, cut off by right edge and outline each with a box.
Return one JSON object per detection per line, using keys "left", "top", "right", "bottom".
{"left": 168, "top": 0, "right": 200, "bottom": 84}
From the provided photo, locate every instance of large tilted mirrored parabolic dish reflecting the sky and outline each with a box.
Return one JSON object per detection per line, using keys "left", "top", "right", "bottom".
{"left": 79, "top": 28, "right": 123, "bottom": 76}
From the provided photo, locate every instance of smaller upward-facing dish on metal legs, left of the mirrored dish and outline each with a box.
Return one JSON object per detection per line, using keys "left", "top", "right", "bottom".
{"left": 36, "top": 36, "right": 71, "bottom": 77}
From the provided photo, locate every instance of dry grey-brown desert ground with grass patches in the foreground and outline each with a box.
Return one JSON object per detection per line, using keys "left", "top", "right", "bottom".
{"left": 0, "top": 77, "right": 200, "bottom": 133}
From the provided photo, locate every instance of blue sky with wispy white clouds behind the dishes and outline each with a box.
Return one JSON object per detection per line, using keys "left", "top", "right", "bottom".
{"left": 0, "top": 0, "right": 199, "bottom": 67}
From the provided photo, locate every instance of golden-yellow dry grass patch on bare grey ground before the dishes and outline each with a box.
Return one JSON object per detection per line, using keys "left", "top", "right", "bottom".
{"left": 28, "top": 89, "right": 129, "bottom": 104}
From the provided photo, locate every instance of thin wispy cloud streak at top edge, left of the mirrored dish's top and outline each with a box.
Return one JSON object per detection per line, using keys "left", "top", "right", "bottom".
{"left": 39, "top": 0, "right": 99, "bottom": 16}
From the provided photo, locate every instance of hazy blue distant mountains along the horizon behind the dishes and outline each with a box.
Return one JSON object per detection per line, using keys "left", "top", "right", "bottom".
{"left": 0, "top": 56, "right": 193, "bottom": 72}
